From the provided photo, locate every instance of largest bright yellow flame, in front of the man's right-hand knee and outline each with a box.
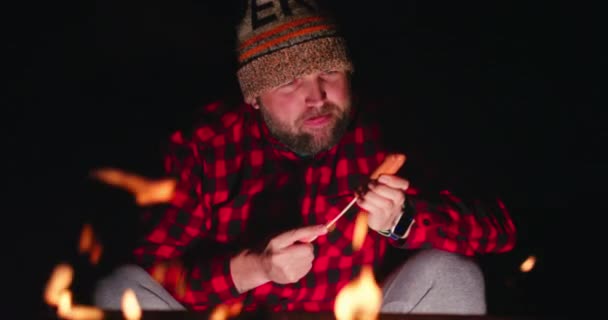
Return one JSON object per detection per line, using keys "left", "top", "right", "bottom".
{"left": 334, "top": 266, "right": 382, "bottom": 320}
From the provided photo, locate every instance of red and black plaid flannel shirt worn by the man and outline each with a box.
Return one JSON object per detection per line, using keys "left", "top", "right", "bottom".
{"left": 134, "top": 102, "right": 515, "bottom": 312}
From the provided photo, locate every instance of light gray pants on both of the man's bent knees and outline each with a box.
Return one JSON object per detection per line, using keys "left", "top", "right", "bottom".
{"left": 93, "top": 250, "right": 486, "bottom": 315}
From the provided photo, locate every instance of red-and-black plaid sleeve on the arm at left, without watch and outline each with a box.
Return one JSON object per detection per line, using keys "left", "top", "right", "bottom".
{"left": 133, "top": 132, "right": 239, "bottom": 310}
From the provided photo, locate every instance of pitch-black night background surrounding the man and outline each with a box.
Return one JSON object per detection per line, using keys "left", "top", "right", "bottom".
{"left": 3, "top": 0, "right": 605, "bottom": 315}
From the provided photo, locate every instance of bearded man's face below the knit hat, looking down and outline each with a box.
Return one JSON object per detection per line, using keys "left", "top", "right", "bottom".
{"left": 254, "top": 71, "right": 351, "bottom": 155}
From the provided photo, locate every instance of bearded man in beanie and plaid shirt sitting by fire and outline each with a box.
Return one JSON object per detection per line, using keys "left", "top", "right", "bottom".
{"left": 95, "top": 0, "right": 515, "bottom": 314}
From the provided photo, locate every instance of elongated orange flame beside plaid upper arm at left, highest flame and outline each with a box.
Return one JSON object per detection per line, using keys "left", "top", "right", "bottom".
{"left": 92, "top": 168, "right": 177, "bottom": 206}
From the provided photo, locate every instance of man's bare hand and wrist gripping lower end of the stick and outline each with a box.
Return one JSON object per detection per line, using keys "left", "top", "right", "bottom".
{"left": 230, "top": 225, "right": 327, "bottom": 293}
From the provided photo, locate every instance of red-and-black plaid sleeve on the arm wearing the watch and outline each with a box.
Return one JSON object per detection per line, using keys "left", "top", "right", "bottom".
{"left": 389, "top": 188, "right": 516, "bottom": 256}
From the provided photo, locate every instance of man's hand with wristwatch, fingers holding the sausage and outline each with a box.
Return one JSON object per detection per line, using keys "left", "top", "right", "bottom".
{"left": 357, "top": 175, "right": 409, "bottom": 231}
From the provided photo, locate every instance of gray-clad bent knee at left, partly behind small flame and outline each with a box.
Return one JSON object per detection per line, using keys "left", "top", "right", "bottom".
{"left": 93, "top": 264, "right": 184, "bottom": 310}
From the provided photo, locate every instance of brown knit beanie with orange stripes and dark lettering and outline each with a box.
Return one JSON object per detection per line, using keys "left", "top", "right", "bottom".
{"left": 237, "top": 0, "right": 353, "bottom": 103}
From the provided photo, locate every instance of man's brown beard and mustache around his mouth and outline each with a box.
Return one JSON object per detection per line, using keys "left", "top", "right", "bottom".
{"left": 260, "top": 102, "right": 351, "bottom": 156}
